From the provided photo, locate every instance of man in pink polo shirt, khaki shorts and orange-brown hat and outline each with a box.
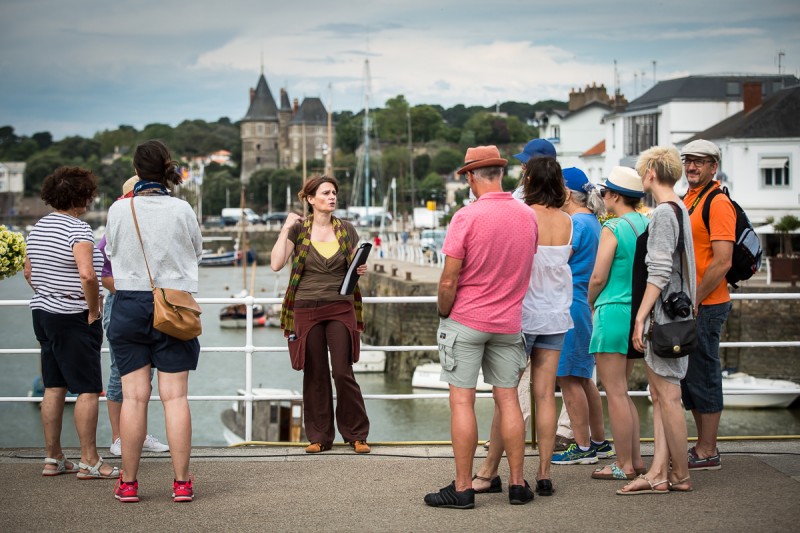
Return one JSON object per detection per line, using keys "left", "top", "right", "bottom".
{"left": 425, "top": 146, "right": 538, "bottom": 509}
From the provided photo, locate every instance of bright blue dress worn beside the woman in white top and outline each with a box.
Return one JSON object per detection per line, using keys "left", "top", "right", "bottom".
{"left": 557, "top": 213, "right": 601, "bottom": 378}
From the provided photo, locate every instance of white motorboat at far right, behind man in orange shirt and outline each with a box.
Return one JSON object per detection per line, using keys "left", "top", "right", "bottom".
{"left": 647, "top": 370, "right": 800, "bottom": 409}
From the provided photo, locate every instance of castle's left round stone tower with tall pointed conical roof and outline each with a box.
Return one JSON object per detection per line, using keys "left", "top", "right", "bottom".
{"left": 241, "top": 73, "right": 280, "bottom": 184}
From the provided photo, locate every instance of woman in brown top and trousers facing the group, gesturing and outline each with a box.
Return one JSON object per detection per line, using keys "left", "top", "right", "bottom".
{"left": 270, "top": 176, "right": 370, "bottom": 453}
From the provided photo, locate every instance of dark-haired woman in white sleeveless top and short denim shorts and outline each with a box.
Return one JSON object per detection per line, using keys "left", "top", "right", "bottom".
{"left": 473, "top": 157, "right": 572, "bottom": 496}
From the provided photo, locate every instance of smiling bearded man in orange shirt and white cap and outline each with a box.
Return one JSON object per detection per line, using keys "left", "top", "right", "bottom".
{"left": 681, "top": 139, "right": 736, "bottom": 470}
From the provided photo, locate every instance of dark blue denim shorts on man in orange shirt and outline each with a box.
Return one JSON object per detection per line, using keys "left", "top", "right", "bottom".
{"left": 681, "top": 302, "right": 731, "bottom": 414}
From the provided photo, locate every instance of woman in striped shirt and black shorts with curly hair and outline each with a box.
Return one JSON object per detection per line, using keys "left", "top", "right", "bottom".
{"left": 25, "top": 167, "right": 119, "bottom": 479}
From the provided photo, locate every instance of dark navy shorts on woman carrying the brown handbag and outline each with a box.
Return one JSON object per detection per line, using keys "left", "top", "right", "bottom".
{"left": 108, "top": 291, "right": 200, "bottom": 376}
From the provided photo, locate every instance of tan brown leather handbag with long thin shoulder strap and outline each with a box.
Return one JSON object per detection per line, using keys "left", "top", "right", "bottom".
{"left": 131, "top": 198, "right": 203, "bottom": 341}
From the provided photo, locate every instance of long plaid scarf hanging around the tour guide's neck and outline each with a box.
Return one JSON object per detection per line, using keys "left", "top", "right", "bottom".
{"left": 281, "top": 214, "right": 364, "bottom": 338}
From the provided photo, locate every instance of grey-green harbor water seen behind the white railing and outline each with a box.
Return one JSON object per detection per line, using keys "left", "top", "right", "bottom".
{"left": 0, "top": 267, "right": 800, "bottom": 449}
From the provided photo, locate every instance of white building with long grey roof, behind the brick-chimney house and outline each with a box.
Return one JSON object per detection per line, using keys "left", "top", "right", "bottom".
{"left": 603, "top": 75, "right": 798, "bottom": 175}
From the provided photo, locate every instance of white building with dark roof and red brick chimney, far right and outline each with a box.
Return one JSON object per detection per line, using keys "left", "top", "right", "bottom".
{"left": 681, "top": 82, "right": 800, "bottom": 225}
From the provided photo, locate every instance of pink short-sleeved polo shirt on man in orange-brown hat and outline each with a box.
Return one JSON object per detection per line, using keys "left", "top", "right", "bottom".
{"left": 442, "top": 192, "right": 539, "bottom": 333}
